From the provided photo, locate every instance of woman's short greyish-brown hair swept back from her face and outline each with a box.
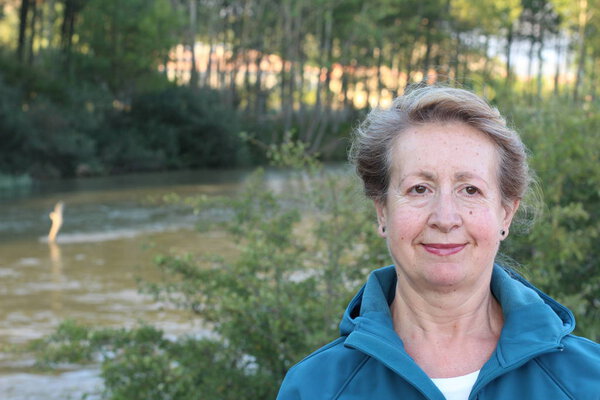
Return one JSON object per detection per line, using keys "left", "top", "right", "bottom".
{"left": 350, "top": 86, "right": 533, "bottom": 208}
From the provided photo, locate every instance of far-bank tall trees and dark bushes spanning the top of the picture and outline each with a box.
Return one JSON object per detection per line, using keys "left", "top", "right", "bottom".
{"left": 0, "top": 0, "right": 600, "bottom": 177}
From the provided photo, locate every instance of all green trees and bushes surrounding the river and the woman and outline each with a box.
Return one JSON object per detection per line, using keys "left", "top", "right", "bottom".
{"left": 0, "top": 0, "right": 600, "bottom": 400}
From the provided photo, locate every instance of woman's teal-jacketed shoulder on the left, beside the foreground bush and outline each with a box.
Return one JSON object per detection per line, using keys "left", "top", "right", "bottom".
{"left": 277, "top": 337, "right": 369, "bottom": 400}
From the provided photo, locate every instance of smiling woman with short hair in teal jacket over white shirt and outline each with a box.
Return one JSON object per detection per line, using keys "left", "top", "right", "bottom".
{"left": 278, "top": 87, "right": 600, "bottom": 400}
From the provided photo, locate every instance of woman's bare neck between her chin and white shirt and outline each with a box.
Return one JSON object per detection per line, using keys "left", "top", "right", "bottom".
{"left": 391, "top": 271, "right": 504, "bottom": 378}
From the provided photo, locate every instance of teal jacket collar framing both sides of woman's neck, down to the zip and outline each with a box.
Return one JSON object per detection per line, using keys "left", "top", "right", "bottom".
{"left": 340, "top": 265, "right": 575, "bottom": 399}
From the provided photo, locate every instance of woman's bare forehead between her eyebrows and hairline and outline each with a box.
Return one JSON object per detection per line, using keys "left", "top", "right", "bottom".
{"left": 390, "top": 122, "right": 499, "bottom": 179}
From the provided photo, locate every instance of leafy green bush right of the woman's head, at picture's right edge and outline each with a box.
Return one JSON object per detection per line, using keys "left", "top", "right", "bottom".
{"left": 496, "top": 98, "right": 600, "bottom": 341}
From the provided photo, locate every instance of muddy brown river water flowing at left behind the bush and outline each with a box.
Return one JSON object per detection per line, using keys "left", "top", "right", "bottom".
{"left": 0, "top": 170, "right": 255, "bottom": 400}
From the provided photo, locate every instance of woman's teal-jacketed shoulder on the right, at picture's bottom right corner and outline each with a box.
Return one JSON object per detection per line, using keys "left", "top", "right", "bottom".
{"left": 537, "top": 335, "right": 600, "bottom": 399}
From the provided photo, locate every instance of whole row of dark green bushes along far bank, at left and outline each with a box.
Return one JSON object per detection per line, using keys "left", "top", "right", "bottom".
{"left": 0, "top": 57, "right": 251, "bottom": 178}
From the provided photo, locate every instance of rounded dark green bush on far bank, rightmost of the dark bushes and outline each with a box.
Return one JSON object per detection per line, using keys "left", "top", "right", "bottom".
{"left": 96, "top": 87, "right": 248, "bottom": 172}
